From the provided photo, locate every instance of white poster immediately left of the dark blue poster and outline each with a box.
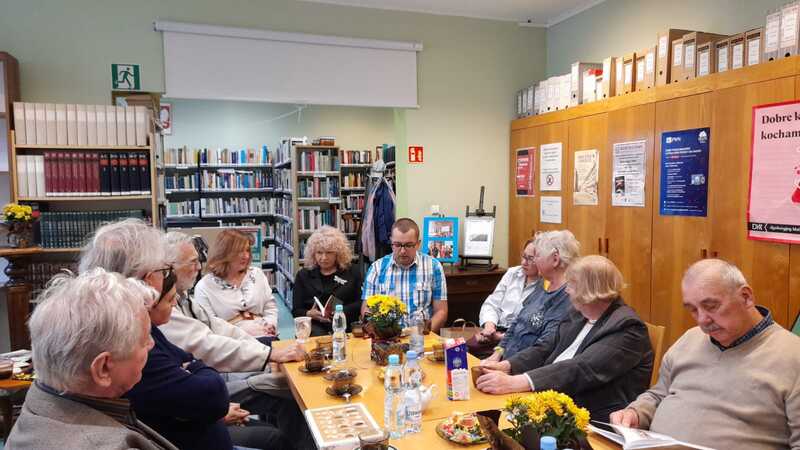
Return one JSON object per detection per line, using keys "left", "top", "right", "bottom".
{"left": 611, "top": 141, "right": 647, "bottom": 208}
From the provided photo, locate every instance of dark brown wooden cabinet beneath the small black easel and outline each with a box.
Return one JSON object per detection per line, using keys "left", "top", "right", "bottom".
{"left": 445, "top": 268, "right": 506, "bottom": 324}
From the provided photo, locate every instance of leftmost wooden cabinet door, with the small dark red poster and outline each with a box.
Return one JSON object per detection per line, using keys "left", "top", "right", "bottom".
{"left": 508, "top": 128, "right": 539, "bottom": 260}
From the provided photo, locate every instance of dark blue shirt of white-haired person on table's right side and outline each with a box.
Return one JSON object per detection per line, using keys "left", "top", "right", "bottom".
{"left": 500, "top": 279, "right": 572, "bottom": 359}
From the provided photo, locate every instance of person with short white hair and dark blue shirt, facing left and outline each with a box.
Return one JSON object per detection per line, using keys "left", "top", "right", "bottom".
{"left": 484, "top": 230, "right": 580, "bottom": 362}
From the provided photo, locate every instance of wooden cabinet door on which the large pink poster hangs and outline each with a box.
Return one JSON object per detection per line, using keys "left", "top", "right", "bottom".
{"left": 709, "top": 77, "right": 795, "bottom": 326}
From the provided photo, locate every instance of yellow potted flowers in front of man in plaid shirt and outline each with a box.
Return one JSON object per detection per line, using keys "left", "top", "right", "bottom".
{"left": 364, "top": 295, "right": 408, "bottom": 366}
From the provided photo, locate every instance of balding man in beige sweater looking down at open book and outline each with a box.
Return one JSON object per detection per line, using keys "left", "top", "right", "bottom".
{"left": 611, "top": 259, "right": 800, "bottom": 450}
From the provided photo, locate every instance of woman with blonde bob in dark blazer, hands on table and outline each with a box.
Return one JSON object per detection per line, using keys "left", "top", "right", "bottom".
{"left": 478, "top": 255, "right": 653, "bottom": 422}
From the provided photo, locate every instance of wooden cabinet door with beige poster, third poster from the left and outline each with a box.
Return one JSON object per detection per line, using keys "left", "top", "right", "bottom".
{"left": 563, "top": 113, "right": 608, "bottom": 255}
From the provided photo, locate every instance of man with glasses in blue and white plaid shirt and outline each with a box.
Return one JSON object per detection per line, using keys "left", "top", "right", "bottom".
{"left": 361, "top": 218, "right": 447, "bottom": 332}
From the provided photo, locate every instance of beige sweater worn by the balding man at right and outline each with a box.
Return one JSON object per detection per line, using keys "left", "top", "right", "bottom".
{"left": 630, "top": 324, "right": 800, "bottom": 450}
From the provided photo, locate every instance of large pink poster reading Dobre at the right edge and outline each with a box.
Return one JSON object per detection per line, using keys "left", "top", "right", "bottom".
{"left": 747, "top": 101, "right": 800, "bottom": 244}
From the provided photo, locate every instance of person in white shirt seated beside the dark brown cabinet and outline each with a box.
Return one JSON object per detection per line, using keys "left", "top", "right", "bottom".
{"left": 467, "top": 238, "right": 541, "bottom": 359}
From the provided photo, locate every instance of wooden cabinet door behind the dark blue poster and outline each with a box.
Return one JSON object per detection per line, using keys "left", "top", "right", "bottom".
{"left": 651, "top": 93, "right": 717, "bottom": 346}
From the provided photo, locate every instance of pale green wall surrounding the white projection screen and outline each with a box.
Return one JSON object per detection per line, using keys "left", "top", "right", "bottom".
{"left": 0, "top": 0, "right": 545, "bottom": 270}
